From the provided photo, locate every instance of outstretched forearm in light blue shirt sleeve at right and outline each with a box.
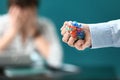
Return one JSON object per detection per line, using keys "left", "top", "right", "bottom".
{"left": 89, "top": 20, "right": 120, "bottom": 48}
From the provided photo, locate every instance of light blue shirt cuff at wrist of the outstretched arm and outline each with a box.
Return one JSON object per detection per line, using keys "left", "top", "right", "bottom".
{"left": 88, "top": 23, "right": 113, "bottom": 49}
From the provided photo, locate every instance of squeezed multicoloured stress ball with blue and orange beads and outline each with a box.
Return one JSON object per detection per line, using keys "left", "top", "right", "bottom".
{"left": 66, "top": 21, "right": 85, "bottom": 39}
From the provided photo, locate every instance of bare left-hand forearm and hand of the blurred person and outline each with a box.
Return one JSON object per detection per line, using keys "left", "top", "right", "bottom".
{"left": 0, "top": 8, "right": 23, "bottom": 51}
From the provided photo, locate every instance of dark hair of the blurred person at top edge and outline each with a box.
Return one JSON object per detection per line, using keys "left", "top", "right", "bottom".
{"left": 8, "top": 0, "right": 41, "bottom": 8}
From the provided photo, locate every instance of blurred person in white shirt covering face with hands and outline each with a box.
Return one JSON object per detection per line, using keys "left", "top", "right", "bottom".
{"left": 0, "top": 0, "right": 78, "bottom": 75}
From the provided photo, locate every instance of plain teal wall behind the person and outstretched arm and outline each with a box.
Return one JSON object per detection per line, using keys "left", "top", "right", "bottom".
{"left": 0, "top": 0, "right": 120, "bottom": 79}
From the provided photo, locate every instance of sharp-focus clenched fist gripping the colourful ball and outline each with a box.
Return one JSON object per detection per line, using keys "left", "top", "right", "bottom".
{"left": 61, "top": 22, "right": 91, "bottom": 50}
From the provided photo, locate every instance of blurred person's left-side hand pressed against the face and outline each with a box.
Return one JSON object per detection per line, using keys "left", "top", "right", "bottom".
{"left": 9, "top": 7, "right": 27, "bottom": 31}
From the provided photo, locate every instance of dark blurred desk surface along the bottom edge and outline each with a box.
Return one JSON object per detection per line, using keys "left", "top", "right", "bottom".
{"left": 0, "top": 66, "right": 117, "bottom": 80}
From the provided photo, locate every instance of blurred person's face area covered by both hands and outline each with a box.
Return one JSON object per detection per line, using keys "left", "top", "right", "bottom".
{"left": 9, "top": 7, "right": 38, "bottom": 35}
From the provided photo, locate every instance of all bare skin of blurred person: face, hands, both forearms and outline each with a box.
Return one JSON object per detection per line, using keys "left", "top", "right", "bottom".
{"left": 0, "top": 5, "right": 50, "bottom": 58}
